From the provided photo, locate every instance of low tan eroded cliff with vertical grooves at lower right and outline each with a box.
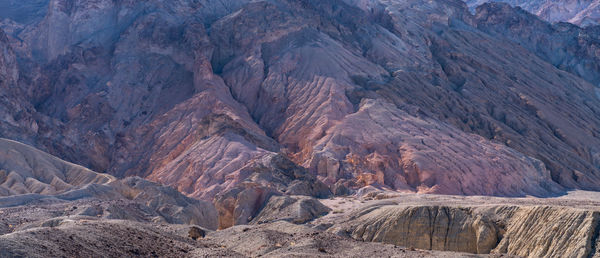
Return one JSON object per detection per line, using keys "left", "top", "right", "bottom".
{"left": 329, "top": 197, "right": 600, "bottom": 257}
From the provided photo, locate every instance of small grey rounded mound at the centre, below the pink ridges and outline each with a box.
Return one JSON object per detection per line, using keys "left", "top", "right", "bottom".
{"left": 251, "top": 196, "right": 331, "bottom": 224}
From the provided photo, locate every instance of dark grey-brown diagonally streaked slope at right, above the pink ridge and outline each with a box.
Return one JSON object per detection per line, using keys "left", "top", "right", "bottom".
{"left": 359, "top": 0, "right": 598, "bottom": 189}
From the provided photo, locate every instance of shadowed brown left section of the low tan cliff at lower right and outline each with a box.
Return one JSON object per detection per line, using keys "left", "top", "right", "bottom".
{"left": 346, "top": 206, "right": 499, "bottom": 254}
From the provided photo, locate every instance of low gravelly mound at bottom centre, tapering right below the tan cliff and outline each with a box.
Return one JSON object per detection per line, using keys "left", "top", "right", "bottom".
{"left": 202, "top": 221, "right": 482, "bottom": 257}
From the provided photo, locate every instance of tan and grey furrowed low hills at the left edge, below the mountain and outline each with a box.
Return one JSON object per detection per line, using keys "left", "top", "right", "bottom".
{"left": 0, "top": 139, "right": 218, "bottom": 230}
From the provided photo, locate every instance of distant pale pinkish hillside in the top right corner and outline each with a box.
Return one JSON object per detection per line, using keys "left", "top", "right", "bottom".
{"left": 465, "top": 0, "right": 600, "bottom": 26}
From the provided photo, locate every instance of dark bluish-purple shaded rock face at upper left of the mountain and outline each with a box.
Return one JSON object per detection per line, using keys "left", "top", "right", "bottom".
{"left": 0, "top": 0, "right": 256, "bottom": 173}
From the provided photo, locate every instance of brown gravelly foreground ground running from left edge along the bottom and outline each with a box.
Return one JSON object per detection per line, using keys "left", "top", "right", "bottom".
{"left": 0, "top": 197, "right": 494, "bottom": 257}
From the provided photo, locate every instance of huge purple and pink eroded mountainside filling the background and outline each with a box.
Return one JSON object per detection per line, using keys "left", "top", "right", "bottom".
{"left": 1, "top": 0, "right": 600, "bottom": 203}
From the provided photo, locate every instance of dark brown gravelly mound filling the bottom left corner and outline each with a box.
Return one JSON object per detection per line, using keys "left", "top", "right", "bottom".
{"left": 0, "top": 220, "right": 200, "bottom": 257}
